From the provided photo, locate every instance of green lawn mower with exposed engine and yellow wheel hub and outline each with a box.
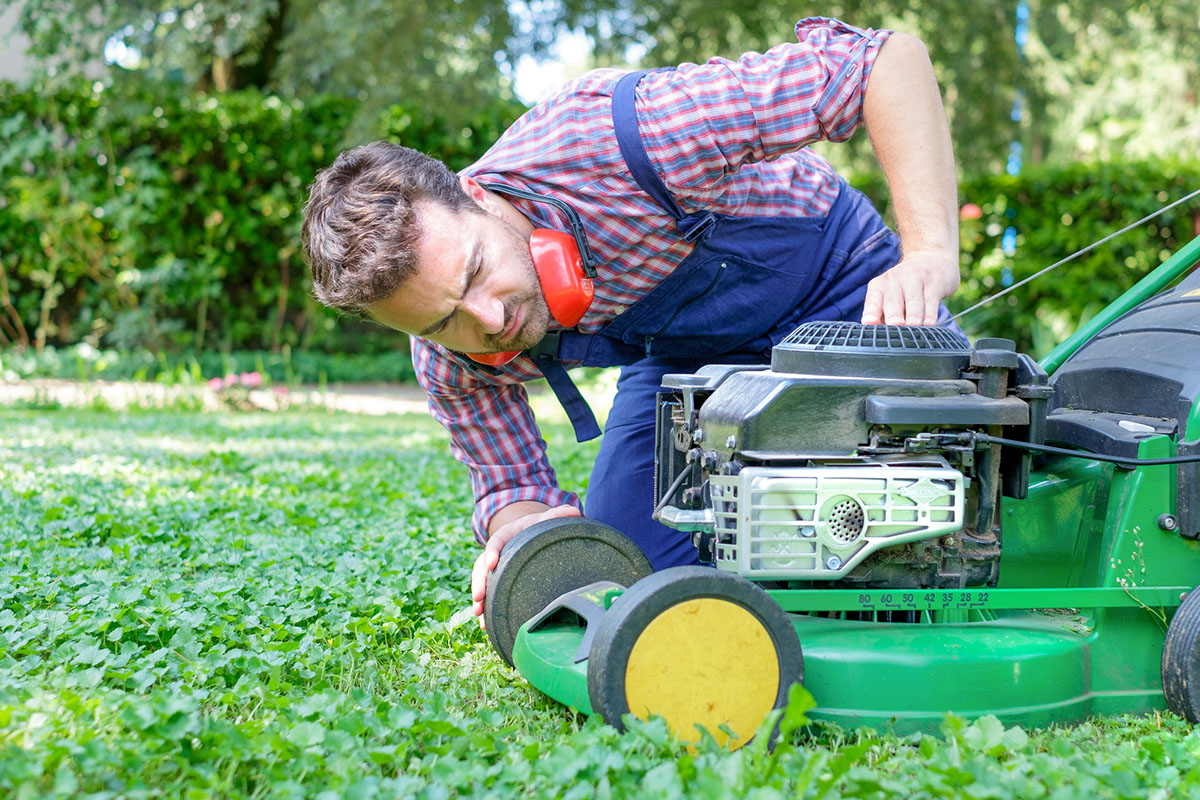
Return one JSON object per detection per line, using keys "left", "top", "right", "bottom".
{"left": 485, "top": 221, "right": 1200, "bottom": 746}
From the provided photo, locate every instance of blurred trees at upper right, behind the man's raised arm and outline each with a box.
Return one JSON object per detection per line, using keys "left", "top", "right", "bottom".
{"left": 563, "top": 0, "right": 1200, "bottom": 174}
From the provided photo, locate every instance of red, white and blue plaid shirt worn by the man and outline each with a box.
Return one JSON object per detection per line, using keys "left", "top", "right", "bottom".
{"left": 412, "top": 18, "right": 890, "bottom": 542}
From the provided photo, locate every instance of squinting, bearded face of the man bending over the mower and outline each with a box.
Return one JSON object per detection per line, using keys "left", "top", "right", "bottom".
{"left": 367, "top": 203, "right": 550, "bottom": 353}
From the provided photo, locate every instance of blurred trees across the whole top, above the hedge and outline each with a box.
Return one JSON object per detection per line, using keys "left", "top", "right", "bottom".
{"left": 9, "top": 0, "right": 1200, "bottom": 174}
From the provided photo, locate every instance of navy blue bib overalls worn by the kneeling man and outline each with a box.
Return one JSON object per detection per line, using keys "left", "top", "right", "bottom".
{"left": 530, "top": 72, "right": 949, "bottom": 570}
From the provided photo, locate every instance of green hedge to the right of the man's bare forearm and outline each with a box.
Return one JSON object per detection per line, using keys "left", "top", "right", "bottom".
{"left": 853, "top": 161, "right": 1200, "bottom": 356}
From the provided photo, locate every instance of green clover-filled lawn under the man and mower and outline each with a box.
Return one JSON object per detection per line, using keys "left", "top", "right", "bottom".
{"left": 0, "top": 410, "right": 1200, "bottom": 800}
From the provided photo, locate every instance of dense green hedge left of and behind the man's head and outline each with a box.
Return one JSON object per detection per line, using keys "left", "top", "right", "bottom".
{"left": 0, "top": 80, "right": 523, "bottom": 353}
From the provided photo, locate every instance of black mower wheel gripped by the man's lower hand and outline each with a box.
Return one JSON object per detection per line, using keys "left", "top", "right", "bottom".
{"left": 484, "top": 517, "right": 654, "bottom": 666}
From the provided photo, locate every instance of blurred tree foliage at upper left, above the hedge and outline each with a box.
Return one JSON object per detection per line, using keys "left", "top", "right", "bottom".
{"left": 0, "top": 0, "right": 525, "bottom": 139}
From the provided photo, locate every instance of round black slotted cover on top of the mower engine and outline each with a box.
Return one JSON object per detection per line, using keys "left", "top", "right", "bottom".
{"left": 770, "top": 321, "right": 971, "bottom": 380}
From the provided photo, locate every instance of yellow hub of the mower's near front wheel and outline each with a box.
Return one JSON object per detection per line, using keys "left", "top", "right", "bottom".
{"left": 625, "top": 597, "right": 779, "bottom": 747}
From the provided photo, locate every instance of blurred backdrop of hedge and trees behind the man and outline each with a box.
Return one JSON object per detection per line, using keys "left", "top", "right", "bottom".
{"left": 0, "top": 0, "right": 1200, "bottom": 381}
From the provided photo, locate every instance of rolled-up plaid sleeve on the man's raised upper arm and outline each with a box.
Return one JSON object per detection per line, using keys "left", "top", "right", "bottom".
{"left": 637, "top": 17, "right": 892, "bottom": 199}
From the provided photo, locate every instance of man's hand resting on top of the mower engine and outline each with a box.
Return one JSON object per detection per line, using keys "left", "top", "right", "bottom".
{"left": 863, "top": 251, "right": 959, "bottom": 325}
